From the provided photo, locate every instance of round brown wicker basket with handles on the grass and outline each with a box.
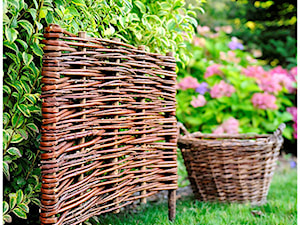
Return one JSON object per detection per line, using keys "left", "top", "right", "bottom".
{"left": 178, "top": 124, "right": 285, "bottom": 205}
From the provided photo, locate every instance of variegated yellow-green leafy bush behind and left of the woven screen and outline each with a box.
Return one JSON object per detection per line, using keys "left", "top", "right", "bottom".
{"left": 3, "top": 0, "right": 203, "bottom": 224}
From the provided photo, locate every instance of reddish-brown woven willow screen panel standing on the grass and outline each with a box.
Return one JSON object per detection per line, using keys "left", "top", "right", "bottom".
{"left": 40, "top": 24, "right": 178, "bottom": 225}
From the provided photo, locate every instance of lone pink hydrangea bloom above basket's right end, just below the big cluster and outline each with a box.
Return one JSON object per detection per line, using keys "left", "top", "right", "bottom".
{"left": 251, "top": 92, "right": 278, "bottom": 109}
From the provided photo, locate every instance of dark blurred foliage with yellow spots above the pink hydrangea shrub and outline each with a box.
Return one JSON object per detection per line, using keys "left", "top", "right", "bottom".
{"left": 198, "top": 0, "right": 297, "bottom": 69}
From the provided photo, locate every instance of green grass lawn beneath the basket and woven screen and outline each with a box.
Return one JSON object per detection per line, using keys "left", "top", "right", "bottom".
{"left": 91, "top": 169, "right": 297, "bottom": 225}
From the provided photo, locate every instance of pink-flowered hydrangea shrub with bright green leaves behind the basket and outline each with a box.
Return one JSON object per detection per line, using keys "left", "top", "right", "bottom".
{"left": 177, "top": 26, "right": 297, "bottom": 140}
